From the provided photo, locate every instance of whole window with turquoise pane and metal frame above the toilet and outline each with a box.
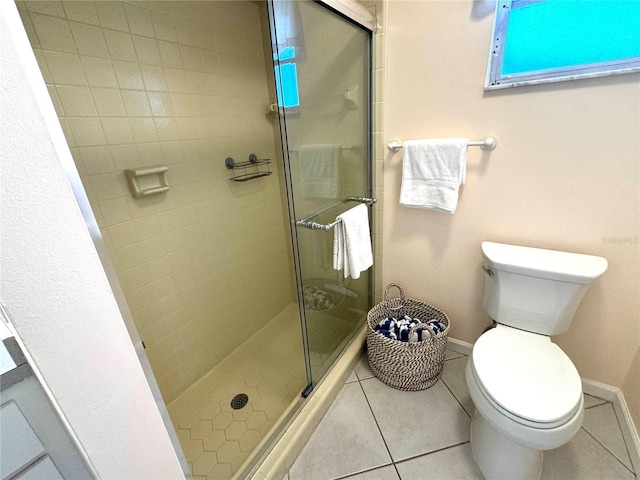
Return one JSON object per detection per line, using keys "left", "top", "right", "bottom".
{"left": 485, "top": 0, "right": 640, "bottom": 89}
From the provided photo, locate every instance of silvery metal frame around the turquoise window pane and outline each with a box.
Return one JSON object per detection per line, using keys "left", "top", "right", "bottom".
{"left": 484, "top": 0, "right": 640, "bottom": 90}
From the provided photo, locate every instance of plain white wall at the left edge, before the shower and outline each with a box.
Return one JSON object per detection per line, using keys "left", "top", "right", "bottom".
{"left": 0, "top": 2, "right": 183, "bottom": 479}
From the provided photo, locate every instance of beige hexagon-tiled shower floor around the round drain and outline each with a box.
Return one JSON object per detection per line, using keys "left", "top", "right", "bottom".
{"left": 168, "top": 304, "right": 306, "bottom": 480}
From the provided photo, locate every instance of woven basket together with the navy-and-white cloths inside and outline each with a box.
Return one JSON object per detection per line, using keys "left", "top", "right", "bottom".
{"left": 367, "top": 283, "right": 450, "bottom": 390}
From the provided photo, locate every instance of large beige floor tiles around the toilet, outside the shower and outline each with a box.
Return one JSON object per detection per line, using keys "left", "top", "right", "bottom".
{"left": 283, "top": 351, "right": 637, "bottom": 480}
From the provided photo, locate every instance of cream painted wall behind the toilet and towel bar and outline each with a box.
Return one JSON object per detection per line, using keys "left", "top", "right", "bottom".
{"left": 383, "top": 0, "right": 640, "bottom": 421}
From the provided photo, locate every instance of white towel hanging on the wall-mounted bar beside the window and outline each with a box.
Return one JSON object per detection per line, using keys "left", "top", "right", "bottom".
{"left": 400, "top": 138, "right": 469, "bottom": 213}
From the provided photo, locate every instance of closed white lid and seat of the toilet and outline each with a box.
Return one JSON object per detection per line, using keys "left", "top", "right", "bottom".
{"left": 470, "top": 325, "right": 582, "bottom": 429}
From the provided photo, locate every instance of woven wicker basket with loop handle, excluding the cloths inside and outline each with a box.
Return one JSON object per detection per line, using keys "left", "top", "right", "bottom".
{"left": 367, "top": 283, "right": 450, "bottom": 390}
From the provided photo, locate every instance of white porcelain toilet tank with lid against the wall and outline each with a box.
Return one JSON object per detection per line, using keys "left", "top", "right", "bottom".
{"left": 482, "top": 242, "right": 607, "bottom": 335}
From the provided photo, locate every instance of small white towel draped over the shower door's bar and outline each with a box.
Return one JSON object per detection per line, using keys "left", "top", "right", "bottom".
{"left": 333, "top": 203, "right": 373, "bottom": 278}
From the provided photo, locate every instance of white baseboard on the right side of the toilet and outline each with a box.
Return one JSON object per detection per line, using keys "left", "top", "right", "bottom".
{"left": 582, "top": 378, "right": 640, "bottom": 476}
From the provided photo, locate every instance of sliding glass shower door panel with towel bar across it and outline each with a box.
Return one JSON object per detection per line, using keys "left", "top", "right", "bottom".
{"left": 270, "top": 0, "right": 373, "bottom": 384}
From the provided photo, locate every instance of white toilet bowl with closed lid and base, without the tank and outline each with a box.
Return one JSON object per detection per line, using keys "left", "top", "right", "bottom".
{"left": 465, "top": 325, "right": 584, "bottom": 480}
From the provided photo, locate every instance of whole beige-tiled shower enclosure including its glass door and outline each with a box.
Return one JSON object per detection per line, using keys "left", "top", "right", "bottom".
{"left": 16, "top": 0, "right": 374, "bottom": 478}
